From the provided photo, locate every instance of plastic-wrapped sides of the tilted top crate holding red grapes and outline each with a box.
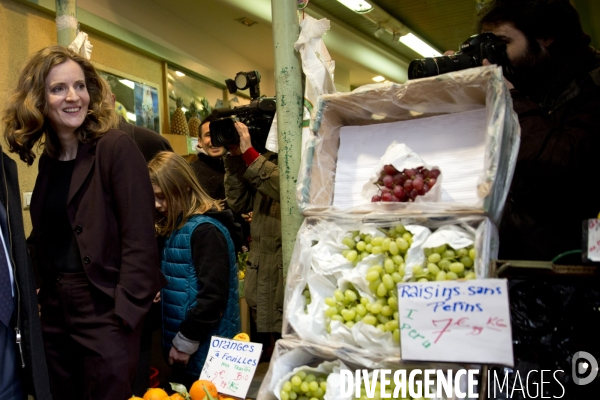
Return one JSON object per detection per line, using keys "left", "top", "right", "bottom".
{"left": 297, "top": 66, "right": 520, "bottom": 221}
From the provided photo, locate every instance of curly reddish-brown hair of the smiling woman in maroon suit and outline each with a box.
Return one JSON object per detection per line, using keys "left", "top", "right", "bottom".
{"left": 3, "top": 46, "right": 118, "bottom": 165}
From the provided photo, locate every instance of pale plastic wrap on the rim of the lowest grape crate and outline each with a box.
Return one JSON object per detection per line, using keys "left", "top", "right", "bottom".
{"left": 257, "top": 339, "right": 479, "bottom": 400}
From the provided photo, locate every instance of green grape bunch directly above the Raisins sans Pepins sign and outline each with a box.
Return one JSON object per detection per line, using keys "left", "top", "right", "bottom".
{"left": 418, "top": 244, "right": 477, "bottom": 282}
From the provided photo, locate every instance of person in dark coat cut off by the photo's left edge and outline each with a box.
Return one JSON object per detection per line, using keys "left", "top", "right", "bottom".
{"left": 0, "top": 147, "right": 52, "bottom": 400}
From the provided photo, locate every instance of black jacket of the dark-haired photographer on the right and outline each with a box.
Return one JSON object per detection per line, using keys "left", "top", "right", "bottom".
{"left": 500, "top": 47, "right": 600, "bottom": 261}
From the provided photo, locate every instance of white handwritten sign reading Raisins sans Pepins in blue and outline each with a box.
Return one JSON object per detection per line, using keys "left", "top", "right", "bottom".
{"left": 398, "top": 279, "right": 513, "bottom": 366}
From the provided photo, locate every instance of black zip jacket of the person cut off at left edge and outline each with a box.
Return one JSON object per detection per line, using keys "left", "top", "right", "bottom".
{"left": 0, "top": 147, "right": 52, "bottom": 400}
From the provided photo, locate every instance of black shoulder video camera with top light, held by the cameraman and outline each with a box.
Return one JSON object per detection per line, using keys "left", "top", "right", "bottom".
{"left": 210, "top": 71, "right": 276, "bottom": 153}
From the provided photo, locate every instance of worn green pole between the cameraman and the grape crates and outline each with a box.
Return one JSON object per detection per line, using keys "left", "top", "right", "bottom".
{"left": 271, "top": 0, "right": 304, "bottom": 276}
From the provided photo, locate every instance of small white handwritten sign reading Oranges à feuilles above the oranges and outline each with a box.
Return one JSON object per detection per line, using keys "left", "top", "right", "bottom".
{"left": 200, "top": 336, "right": 262, "bottom": 398}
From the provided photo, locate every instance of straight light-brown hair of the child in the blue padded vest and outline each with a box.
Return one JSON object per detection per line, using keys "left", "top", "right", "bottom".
{"left": 148, "top": 151, "right": 223, "bottom": 236}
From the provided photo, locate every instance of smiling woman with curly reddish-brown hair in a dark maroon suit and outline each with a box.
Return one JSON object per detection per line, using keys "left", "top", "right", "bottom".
{"left": 3, "top": 46, "right": 164, "bottom": 400}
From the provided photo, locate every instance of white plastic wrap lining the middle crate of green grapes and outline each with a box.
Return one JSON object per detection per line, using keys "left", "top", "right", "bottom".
{"left": 282, "top": 211, "right": 498, "bottom": 357}
